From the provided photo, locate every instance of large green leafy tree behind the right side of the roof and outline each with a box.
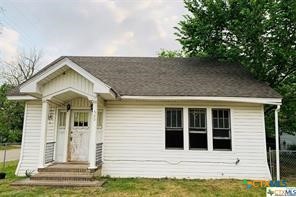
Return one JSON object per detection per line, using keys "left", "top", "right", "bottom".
{"left": 165, "top": 0, "right": 296, "bottom": 134}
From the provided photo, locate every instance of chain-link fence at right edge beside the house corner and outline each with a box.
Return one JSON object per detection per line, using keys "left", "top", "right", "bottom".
{"left": 267, "top": 150, "right": 296, "bottom": 180}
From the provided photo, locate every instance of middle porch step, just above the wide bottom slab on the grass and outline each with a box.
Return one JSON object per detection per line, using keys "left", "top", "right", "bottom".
{"left": 31, "top": 172, "right": 95, "bottom": 181}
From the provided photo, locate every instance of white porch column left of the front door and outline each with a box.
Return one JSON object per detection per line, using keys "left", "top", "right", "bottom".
{"left": 39, "top": 100, "right": 49, "bottom": 168}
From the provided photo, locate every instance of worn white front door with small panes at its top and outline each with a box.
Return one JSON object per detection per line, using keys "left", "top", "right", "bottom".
{"left": 70, "top": 110, "right": 90, "bottom": 161}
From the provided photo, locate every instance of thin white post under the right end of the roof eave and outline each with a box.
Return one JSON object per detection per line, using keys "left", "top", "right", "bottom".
{"left": 274, "top": 105, "right": 281, "bottom": 180}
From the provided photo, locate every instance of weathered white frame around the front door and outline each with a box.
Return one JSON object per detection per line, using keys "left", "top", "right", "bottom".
{"left": 66, "top": 109, "right": 91, "bottom": 161}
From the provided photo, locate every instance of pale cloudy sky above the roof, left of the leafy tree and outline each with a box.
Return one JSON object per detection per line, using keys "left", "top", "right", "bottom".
{"left": 0, "top": 0, "right": 186, "bottom": 65}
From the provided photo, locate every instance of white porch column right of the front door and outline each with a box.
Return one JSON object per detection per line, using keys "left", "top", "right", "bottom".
{"left": 88, "top": 96, "right": 98, "bottom": 169}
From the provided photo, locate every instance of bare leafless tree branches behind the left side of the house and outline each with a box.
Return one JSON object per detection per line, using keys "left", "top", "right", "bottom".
{"left": 1, "top": 49, "right": 41, "bottom": 86}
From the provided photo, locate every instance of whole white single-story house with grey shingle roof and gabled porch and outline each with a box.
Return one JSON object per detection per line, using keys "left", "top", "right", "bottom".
{"left": 8, "top": 56, "right": 281, "bottom": 179}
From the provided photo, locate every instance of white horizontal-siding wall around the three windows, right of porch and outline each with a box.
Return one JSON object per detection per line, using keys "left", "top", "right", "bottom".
{"left": 102, "top": 101, "right": 271, "bottom": 179}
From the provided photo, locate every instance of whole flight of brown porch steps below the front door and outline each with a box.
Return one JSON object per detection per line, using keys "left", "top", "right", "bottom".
{"left": 11, "top": 162, "right": 105, "bottom": 187}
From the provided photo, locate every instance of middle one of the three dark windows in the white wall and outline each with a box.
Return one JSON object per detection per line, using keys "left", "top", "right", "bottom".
{"left": 188, "top": 109, "right": 208, "bottom": 149}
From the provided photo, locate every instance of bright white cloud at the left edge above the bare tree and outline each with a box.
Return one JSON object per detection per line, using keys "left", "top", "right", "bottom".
{"left": 0, "top": 27, "right": 19, "bottom": 61}
